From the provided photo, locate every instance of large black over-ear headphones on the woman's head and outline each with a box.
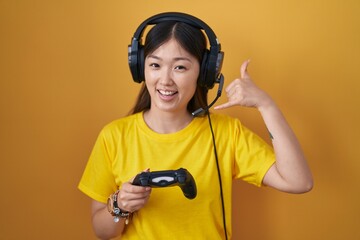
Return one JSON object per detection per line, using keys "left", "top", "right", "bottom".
{"left": 128, "top": 12, "right": 224, "bottom": 89}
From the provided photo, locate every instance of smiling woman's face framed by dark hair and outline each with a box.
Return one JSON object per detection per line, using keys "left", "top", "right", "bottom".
{"left": 145, "top": 39, "right": 200, "bottom": 113}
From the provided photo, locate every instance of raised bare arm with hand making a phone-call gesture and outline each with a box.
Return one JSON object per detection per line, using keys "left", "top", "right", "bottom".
{"left": 215, "top": 61, "right": 313, "bottom": 193}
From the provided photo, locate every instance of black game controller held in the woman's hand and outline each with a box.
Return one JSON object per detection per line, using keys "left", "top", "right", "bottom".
{"left": 132, "top": 168, "right": 197, "bottom": 199}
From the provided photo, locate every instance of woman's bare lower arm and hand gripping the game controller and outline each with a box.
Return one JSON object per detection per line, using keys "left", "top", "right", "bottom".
{"left": 91, "top": 182, "right": 151, "bottom": 239}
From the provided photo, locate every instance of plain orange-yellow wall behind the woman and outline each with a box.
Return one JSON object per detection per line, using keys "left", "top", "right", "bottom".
{"left": 0, "top": 0, "right": 360, "bottom": 240}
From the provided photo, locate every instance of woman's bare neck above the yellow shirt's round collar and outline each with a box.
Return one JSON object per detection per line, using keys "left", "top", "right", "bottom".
{"left": 143, "top": 109, "right": 193, "bottom": 134}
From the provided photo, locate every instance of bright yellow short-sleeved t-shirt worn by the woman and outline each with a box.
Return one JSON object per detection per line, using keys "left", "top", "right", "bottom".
{"left": 79, "top": 113, "right": 275, "bottom": 240}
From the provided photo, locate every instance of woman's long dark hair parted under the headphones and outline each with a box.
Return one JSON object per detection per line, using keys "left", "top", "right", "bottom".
{"left": 130, "top": 21, "right": 208, "bottom": 114}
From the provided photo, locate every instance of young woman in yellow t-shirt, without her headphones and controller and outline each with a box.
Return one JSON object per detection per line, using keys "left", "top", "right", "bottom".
{"left": 79, "top": 12, "right": 312, "bottom": 240}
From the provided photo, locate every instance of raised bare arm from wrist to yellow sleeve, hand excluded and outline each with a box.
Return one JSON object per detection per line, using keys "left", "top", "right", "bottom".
{"left": 259, "top": 97, "right": 313, "bottom": 193}
